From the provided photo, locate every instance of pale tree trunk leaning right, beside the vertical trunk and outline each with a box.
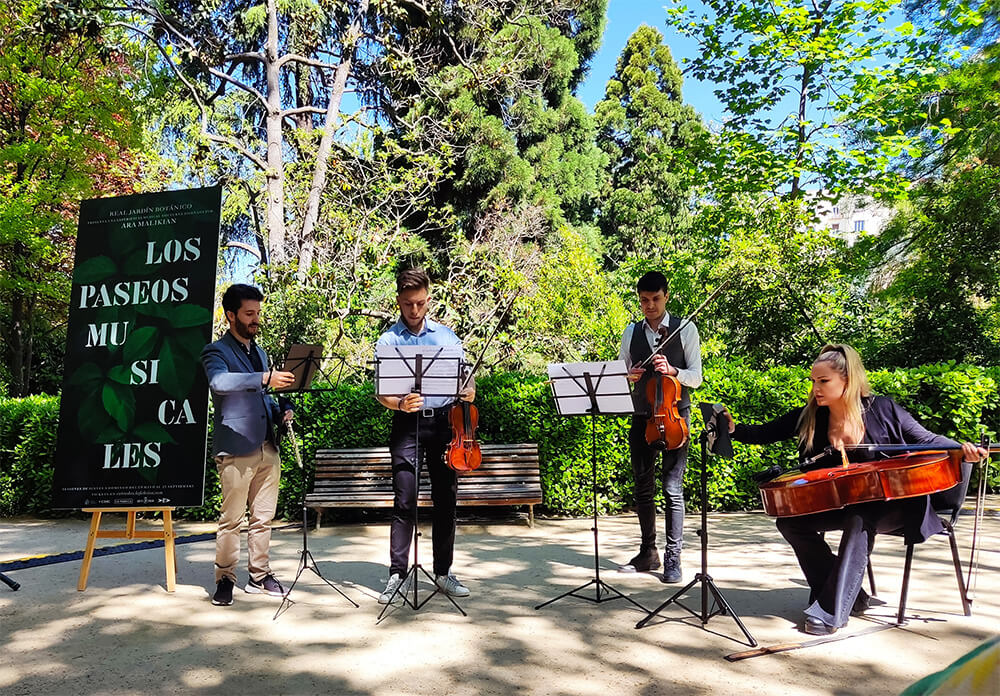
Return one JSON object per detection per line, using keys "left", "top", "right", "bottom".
{"left": 298, "top": 0, "right": 369, "bottom": 281}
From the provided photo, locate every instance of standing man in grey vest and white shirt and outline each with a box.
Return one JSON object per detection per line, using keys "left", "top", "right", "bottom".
{"left": 618, "top": 271, "right": 702, "bottom": 582}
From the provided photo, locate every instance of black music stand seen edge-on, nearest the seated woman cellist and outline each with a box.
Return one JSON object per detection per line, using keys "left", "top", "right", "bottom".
{"left": 635, "top": 403, "right": 757, "bottom": 648}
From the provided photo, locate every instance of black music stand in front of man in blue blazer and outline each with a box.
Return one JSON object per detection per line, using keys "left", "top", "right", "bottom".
{"left": 272, "top": 344, "right": 360, "bottom": 621}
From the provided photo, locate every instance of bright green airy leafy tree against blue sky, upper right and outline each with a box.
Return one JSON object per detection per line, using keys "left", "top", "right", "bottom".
{"left": 668, "top": 0, "right": 964, "bottom": 198}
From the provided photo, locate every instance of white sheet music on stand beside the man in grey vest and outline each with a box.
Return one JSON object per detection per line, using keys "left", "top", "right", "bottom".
{"left": 549, "top": 360, "right": 635, "bottom": 416}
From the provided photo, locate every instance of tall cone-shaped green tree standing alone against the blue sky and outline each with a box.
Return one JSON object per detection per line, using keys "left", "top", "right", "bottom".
{"left": 595, "top": 25, "right": 705, "bottom": 258}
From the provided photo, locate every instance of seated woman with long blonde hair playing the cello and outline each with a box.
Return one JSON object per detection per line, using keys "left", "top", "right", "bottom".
{"left": 726, "top": 344, "right": 986, "bottom": 635}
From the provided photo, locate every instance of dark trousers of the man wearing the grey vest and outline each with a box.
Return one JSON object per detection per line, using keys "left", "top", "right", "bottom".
{"left": 628, "top": 407, "right": 691, "bottom": 556}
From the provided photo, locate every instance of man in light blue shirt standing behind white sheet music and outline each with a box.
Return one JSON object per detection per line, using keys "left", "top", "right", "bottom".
{"left": 378, "top": 268, "right": 476, "bottom": 604}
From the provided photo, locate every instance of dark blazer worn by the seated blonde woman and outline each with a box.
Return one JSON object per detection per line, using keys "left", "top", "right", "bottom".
{"left": 732, "top": 396, "right": 958, "bottom": 543}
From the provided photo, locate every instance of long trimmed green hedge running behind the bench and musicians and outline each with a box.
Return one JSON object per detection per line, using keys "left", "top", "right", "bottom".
{"left": 0, "top": 361, "right": 1000, "bottom": 519}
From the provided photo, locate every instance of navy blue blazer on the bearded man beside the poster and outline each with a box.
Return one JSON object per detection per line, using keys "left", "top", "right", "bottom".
{"left": 201, "top": 331, "right": 291, "bottom": 456}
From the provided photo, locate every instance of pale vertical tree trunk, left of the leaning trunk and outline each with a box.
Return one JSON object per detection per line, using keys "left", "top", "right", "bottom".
{"left": 264, "top": 0, "right": 288, "bottom": 264}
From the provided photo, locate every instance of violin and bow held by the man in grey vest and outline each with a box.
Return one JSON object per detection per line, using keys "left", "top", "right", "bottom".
{"left": 633, "top": 279, "right": 729, "bottom": 451}
